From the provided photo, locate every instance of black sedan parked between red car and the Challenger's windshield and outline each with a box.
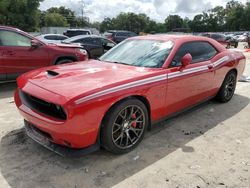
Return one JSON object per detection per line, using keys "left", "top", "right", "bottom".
{"left": 62, "top": 35, "right": 116, "bottom": 59}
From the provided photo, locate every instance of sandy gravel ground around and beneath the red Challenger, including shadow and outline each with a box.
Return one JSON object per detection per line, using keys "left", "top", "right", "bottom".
{"left": 0, "top": 48, "right": 250, "bottom": 188}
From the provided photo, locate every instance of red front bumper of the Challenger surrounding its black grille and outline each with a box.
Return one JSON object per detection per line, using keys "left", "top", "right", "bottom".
{"left": 15, "top": 86, "right": 100, "bottom": 149}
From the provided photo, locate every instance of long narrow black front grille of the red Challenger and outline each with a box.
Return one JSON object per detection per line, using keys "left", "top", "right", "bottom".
{"left": 19, "top": 90, "right": 67, "bottom": 120}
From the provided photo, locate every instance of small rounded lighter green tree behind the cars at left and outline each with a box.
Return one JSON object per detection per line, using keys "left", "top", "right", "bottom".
{"left": 44, "top": 13, "right": 68, "bottom": 27}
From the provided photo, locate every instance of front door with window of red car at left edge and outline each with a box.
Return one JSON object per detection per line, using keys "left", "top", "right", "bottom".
{"left": 0, "top": 30, "right": 48, "bottom": 80}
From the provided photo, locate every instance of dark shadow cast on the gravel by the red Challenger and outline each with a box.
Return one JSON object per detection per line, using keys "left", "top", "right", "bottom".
{"left": 0, "top": 95, "right": 249, "bottom": 188}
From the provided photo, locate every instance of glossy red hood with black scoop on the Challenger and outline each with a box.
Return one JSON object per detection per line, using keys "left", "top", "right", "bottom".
{"left": 19, "top": 60, "right": 159, "bottom": 100}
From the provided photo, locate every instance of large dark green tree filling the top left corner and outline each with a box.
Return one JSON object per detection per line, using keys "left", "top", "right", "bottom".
{"left": 0, "top": 0, "right": 42, "bottom": 31}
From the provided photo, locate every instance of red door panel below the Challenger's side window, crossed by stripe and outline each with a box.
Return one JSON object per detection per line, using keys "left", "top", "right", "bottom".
{"left": 166, "top": 61, "right": 214, "bottom": 115}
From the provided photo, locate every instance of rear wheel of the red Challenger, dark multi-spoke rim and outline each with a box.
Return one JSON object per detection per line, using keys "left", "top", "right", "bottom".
{"left": 215, "top": 71, "right": 237, "bottom": 103}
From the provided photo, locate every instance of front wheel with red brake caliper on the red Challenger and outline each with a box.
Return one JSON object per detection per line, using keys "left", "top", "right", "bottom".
{"left": 101, "top": 98, "right": 149, "bottom": 154}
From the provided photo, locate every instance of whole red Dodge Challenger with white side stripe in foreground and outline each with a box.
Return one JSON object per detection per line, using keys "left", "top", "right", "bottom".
{"left": 15, "top": 35, "right": 245, "bottom": 156}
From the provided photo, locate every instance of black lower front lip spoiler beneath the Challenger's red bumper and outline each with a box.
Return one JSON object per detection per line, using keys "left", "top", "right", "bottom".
{"left": 24, "top": 121, "right": 100, "bottom": 157}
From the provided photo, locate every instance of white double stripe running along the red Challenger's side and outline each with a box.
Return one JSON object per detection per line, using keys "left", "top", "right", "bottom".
{"left": 75, "top": 56, "right": 229, "bottom": 104}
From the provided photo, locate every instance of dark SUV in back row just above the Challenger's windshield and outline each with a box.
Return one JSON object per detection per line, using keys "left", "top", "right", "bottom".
{"left": 104, "top": 30, "right": 137, "bottom": 43}
